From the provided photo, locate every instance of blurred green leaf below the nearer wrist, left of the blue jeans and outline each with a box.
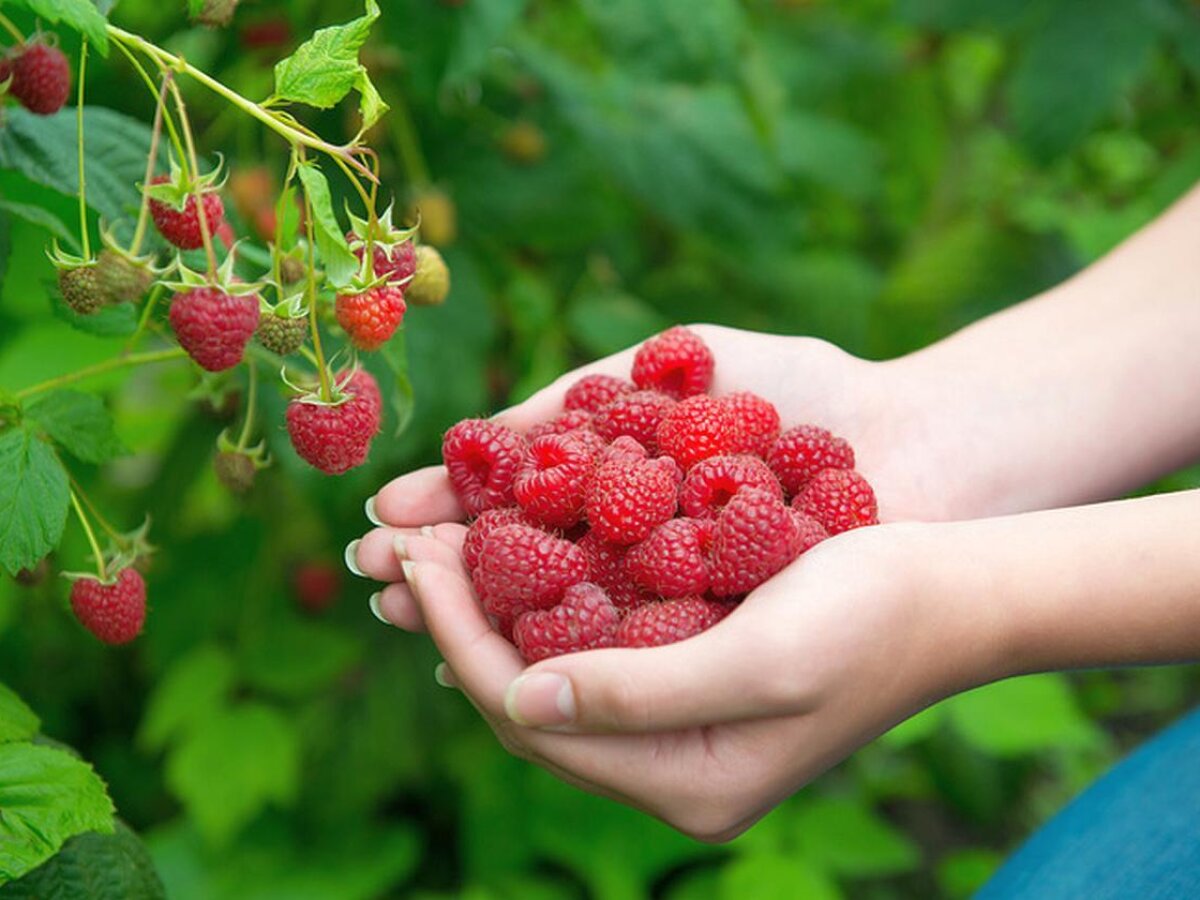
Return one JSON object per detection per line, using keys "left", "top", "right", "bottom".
{"left": 794, "top": 798, "right": 920, "bottom": 878}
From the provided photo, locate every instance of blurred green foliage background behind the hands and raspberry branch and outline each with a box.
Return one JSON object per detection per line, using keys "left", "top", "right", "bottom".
{"left": 0, "top": 0, "right": 1200, "bottom": 900}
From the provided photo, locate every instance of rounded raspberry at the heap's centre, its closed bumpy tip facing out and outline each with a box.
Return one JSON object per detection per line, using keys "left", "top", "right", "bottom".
{"left": 587, "top": 460, "right": 678, "bottom": 545}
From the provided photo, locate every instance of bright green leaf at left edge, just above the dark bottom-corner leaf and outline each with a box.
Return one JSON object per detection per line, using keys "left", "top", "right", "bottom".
{"left": 0, "top": 744, "right": 113, "bottom": 884}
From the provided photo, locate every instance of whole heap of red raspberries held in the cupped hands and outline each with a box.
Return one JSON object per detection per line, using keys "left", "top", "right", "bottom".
{"left": 442, "top": 326, "right": 878, "bottom": 662}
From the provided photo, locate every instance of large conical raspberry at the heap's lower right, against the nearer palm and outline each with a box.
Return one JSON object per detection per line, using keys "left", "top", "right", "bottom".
{"left": 712, "top": 487, "right": 799, "bottom": 596}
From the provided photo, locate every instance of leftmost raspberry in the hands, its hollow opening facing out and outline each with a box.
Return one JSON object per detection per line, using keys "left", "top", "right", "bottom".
{"left": 442, "top": 419, "right": 526, "bottom": 516}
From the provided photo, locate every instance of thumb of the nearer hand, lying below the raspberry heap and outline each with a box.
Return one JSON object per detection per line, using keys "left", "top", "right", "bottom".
{"left": 504, "top": 607, "right": 802, "bottom": 733}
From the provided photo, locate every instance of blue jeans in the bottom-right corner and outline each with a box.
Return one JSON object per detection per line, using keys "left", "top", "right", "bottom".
{"left": 974, "top": 710, "right": 1200, "bottom": 900}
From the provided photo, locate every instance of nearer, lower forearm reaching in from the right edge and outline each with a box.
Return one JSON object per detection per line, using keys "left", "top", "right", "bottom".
{"left": 914, "top": 491, "right": 1200, "bottom": 683}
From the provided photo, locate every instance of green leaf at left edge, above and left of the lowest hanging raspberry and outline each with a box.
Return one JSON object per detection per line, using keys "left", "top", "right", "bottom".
{"left": 0, "top": 428, "right": 71, "bottom": 575}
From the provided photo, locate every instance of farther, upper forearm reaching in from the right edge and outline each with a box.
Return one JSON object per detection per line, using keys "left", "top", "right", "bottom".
{"left": 881, "top": 187, "right": 1200, "bottom": 517}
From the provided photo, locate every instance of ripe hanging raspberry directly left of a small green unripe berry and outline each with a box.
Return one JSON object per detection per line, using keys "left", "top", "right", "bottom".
{"left": 170, "top": 286, "right": 259, "bottom": 372}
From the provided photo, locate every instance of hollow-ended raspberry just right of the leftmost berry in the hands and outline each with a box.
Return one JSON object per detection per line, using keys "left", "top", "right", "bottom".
{"left": 512, "top": 434, "right": 596, "bottom": 528}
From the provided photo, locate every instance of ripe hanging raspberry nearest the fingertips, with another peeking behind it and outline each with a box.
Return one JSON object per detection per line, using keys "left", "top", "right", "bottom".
{"left": 287, "top": 371, "right": 383, "bottom": 475}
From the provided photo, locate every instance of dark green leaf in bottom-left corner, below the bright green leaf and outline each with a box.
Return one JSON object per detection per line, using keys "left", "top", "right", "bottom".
{"left": 4, "top": 820, "right": 167, "bottom": 900}
